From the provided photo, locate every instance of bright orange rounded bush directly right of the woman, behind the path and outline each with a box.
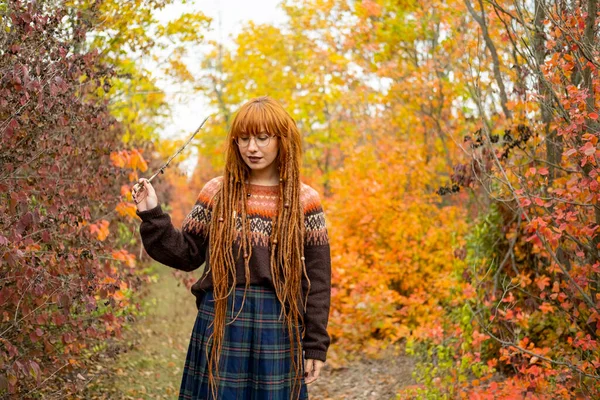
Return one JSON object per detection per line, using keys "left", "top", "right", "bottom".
{"left": 327, "top": 139, "right": 467, "bottom": 353}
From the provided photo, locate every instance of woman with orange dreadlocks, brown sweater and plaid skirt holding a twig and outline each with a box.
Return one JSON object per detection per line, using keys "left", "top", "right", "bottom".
{"left": 133, "top": 96, "right": 331, "bottom": 400}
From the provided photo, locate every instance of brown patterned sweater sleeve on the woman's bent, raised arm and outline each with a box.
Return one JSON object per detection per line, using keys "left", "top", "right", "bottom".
{"left": 136, "top": 181, "right": 218, "bottom": 271}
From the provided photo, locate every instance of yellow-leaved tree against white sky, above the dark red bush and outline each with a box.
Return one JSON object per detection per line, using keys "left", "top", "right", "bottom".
{"left": 66, "top": 0, "right": 210, "bottom": 146}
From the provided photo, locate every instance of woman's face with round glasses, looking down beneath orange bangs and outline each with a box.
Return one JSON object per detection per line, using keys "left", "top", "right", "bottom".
{"left": 237, "top": 132, "right": 279, "bottom": 171}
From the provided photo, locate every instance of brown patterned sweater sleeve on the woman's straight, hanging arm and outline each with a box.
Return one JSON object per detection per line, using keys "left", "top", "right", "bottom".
{"left": 302, "top": 188, "right": 331, "bottom": 361}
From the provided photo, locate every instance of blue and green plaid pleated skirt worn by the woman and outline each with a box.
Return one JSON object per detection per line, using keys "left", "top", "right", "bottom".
{"left": 179, "top": 285, "right": 308, "bottom": 400}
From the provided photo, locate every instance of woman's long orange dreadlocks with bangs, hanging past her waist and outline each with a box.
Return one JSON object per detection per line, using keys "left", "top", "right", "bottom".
{"left": 207, "top": 96, "right": 310, "bottom": 399}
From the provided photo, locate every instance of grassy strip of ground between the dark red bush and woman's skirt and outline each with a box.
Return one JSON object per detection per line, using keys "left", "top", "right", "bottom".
{"left": 86, "top": 263, "right": 200, "bottom": 400}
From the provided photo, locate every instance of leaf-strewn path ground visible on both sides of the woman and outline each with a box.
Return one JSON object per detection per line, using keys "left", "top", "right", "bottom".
{"left": 84, "top": 264, "right": 414, "bottom": 400}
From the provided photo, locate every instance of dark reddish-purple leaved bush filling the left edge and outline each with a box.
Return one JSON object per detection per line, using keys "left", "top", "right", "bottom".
{"left": 0, "top": 2, "right": 146, "bottom": 398}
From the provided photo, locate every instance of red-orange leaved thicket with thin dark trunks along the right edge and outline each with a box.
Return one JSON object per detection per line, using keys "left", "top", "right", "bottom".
{"left": 436, "top": 1, "right": 600, "bottom": 398}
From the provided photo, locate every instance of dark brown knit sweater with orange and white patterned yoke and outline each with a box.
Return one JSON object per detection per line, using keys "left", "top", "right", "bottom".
{"left": 137, "top": 176, "right": 331, "bottom": 361}
